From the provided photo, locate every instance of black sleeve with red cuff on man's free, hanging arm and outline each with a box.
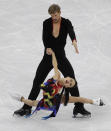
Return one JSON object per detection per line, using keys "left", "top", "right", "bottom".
{"left": 66, "top": 19, "right": 77, "bottom": 42}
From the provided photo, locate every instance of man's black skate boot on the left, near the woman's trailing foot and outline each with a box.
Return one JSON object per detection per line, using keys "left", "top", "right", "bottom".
{"left": 13, "top": 108, "right": 31, "bottom": 116}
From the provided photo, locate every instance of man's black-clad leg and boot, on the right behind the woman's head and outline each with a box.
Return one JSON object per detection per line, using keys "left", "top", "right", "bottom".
{"left": 58, "top": 58, "right": 91, "bottom": 116}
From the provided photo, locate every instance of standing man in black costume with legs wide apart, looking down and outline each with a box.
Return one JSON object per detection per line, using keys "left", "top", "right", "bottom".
{"left": 14, "top": 4, "right": 91, "bottom": 117}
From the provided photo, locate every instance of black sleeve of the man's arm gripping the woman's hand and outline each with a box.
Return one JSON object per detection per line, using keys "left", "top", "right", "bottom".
{"left": 42, "top": 21, "right": 50, "bottom": 48}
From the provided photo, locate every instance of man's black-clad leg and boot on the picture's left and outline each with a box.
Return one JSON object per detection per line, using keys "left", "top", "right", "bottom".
{"left": 14, "top": 55, "right": 53, "bottom": 116}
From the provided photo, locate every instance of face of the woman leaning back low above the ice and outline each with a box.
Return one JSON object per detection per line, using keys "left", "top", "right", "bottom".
{"left": 64, "top": 77, "right": 75, "bottom": 88}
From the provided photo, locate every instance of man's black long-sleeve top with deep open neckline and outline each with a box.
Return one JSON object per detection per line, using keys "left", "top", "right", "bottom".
{"left": 42, "top": 17, "right": 76, "bottom": 56}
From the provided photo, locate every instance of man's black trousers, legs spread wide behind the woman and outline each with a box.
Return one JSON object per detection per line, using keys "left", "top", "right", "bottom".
{"left": 23, "top": 54, "right": 83, "bottom": 108}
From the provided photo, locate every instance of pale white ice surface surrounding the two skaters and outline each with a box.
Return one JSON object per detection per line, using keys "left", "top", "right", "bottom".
{"left": 0, "top": 0, "right": 111, "bottom": 131}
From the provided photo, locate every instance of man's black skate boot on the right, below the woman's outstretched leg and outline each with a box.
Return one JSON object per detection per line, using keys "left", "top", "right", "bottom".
{"left": 73, "top": 103, "right": 91, "bottom": 118}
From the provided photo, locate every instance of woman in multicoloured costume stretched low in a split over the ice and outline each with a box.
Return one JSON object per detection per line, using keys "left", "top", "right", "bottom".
{"left": 16, "top": 48, "right": 104, "bottom": 119}
